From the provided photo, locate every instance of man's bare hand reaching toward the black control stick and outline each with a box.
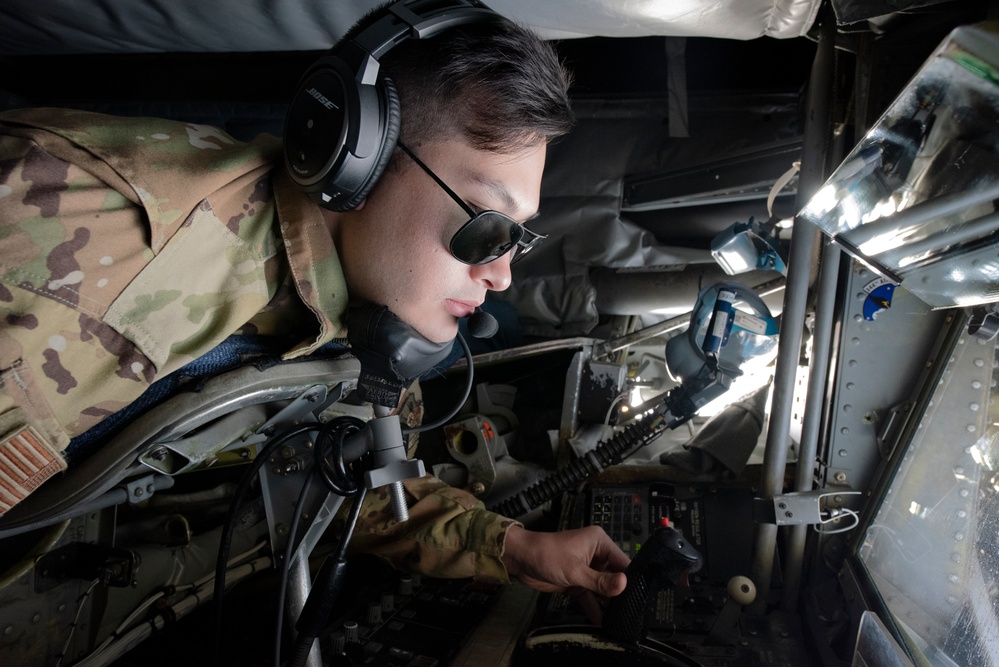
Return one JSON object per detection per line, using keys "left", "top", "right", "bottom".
{"left": 503, "top": 526, "right": 631, "bottom": 597}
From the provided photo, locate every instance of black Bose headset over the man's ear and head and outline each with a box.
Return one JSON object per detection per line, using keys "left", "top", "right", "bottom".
{"left": 284, "top": 0, "right": 496, "bottom": 211}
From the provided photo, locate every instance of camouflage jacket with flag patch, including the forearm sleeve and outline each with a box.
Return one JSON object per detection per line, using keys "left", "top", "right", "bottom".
{"left": 0, "top": 109, "right": 512, "bottom": 581}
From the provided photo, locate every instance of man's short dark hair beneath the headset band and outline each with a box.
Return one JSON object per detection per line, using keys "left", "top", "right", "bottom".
{"left": 382, "top": 17, "right": 574, "bottom": 153}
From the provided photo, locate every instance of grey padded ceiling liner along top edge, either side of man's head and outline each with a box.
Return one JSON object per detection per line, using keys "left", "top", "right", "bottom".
{"left": 0, "top": 0, "right": 820, "bottom": 55}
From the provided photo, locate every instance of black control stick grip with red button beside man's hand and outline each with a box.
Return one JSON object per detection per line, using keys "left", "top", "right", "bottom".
{"left": 603, "top": 526, "right": 702, "bottom": 643}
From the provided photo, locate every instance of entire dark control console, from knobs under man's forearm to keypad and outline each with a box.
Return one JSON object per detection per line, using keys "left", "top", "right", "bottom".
{"left": 324, "top": 482, "right": 810, "bottom": 667}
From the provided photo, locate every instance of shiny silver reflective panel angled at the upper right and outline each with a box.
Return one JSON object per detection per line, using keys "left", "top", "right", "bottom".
{"left": 800, "top": 24, "right": 999, "bottom": 307}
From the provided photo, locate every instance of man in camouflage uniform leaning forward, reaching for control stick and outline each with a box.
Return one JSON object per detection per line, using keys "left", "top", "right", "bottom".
{"left": 0, "top": 9, "right": 628, "bottom": 595}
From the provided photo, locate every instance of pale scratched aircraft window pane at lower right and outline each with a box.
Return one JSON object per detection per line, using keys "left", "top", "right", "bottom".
{"left": 858, "top": 326, "right": 999, "bottom": 667}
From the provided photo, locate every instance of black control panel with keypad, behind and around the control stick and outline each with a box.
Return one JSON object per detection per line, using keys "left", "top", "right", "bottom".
{"left": 514, "top": 482, "right": 809, "bottom": 667}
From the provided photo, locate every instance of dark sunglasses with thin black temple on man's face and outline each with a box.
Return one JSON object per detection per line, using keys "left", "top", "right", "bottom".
{"left": 398, "top": 144, "right": 548, "bottom": 266}
